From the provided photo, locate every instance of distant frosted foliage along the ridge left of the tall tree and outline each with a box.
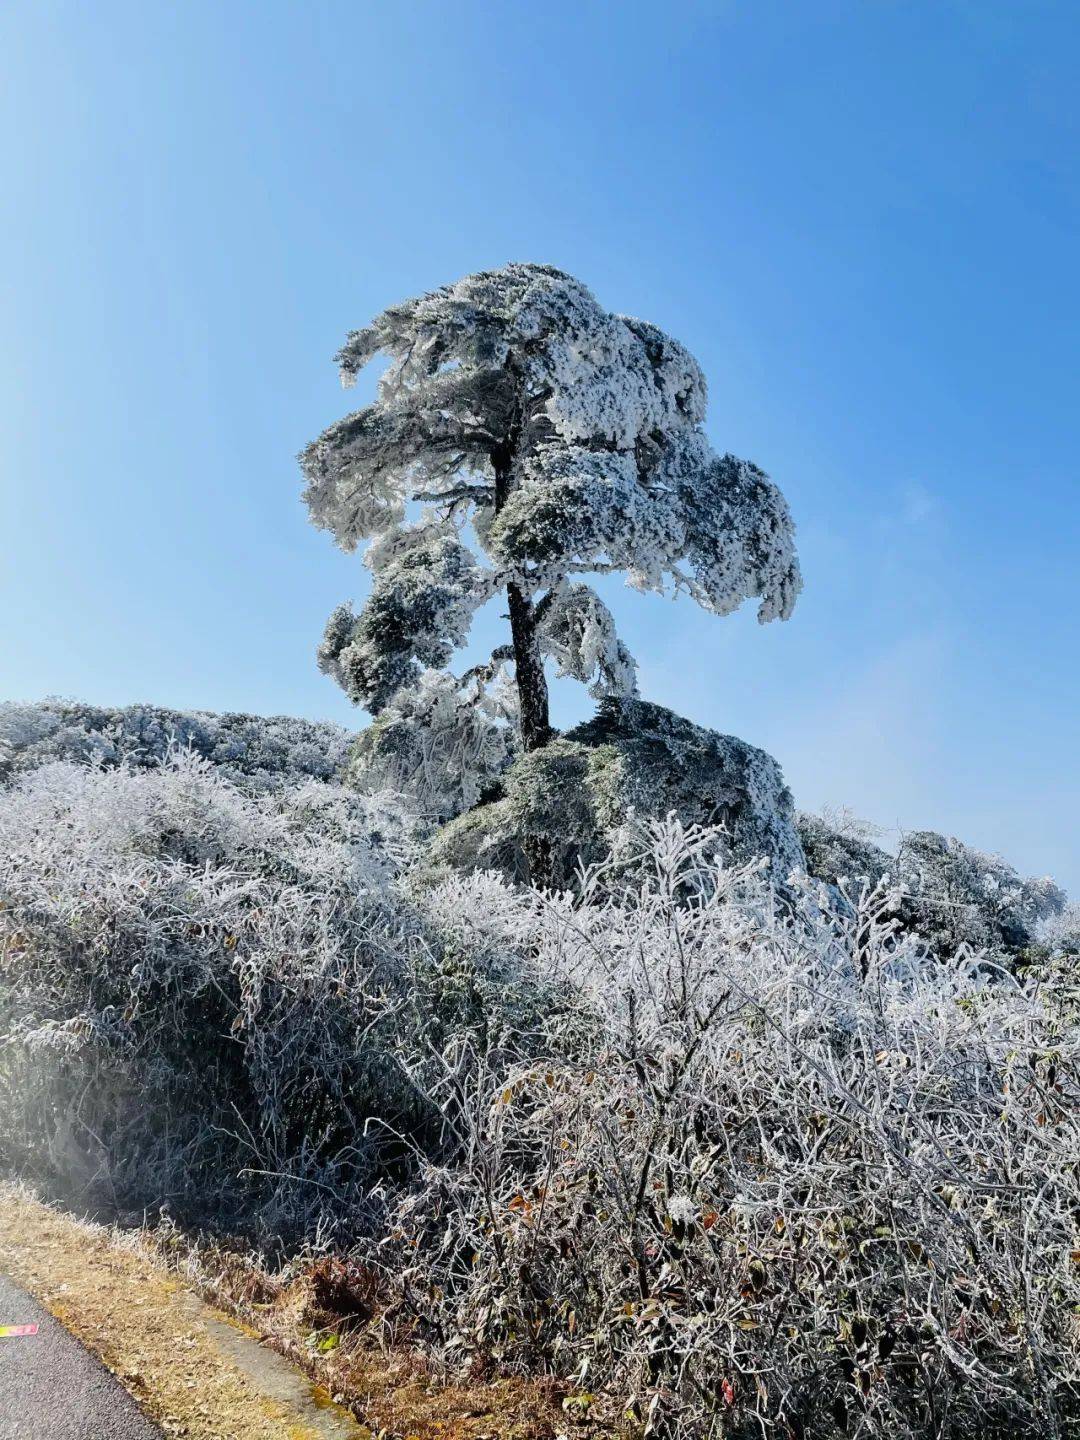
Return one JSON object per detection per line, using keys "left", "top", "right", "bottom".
{"left": 0, "top": 700, "right": 351, "bottom": 783}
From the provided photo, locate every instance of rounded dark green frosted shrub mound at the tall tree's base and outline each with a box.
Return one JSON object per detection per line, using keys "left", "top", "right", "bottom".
{"left": 431, "top": 700, "right": 805, "bottom": 886}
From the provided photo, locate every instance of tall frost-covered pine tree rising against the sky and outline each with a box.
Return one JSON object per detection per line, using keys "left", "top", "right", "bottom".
{"left": 301, "top": 265, "right": 801, "bottom": 750}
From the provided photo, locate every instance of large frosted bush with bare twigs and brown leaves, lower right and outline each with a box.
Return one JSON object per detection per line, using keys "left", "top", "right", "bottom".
{"left": 374, "top": 824, "right": 1080, "bottom": 1440}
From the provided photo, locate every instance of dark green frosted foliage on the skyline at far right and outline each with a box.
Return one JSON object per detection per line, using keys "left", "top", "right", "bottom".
{"left": 798, "top": 815, "right": 1066, "bottom": 956}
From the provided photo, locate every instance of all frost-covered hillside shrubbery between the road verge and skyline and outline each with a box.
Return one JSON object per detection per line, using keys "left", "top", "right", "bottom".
{"left": 0, "top": 704, "right": 1080, "bottom": 1440}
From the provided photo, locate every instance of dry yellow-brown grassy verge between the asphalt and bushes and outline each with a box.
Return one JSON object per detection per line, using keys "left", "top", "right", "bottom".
{"left": 0, "top": 1184, "right": 599, "bottom": 1440}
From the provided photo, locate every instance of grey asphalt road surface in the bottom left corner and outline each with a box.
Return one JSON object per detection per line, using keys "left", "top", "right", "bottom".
{"left": 0, "top": 1274, "right": 161, "bottom": 1440}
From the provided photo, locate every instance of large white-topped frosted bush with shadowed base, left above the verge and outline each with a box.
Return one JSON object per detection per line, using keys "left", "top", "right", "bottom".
{"left": 0, "top": 752, "right": 558, "bottom": 1238}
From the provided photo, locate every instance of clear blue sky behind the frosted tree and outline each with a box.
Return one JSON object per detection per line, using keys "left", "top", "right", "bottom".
{"left": 0, "top": 0, "right": 1080, "bottom": 891}
